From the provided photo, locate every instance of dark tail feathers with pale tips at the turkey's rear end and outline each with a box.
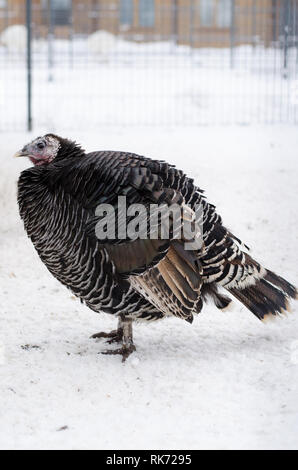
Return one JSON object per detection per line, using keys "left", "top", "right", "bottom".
{"left": 228, "top": 270, "right": 297, "bottom": 320}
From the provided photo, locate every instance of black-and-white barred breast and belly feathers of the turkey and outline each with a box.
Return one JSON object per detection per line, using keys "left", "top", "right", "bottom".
{"left": 18, "top": 162, "right": 163, "bottom": 321}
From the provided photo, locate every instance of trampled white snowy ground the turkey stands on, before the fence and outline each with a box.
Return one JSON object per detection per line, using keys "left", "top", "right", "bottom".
{"left": 0, "top": 126, "right": 298, "bottom": 449}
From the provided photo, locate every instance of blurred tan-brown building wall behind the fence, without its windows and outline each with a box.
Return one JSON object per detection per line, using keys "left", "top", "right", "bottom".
{"left": 0, "top": 0, "right": 288, "bottom": 47}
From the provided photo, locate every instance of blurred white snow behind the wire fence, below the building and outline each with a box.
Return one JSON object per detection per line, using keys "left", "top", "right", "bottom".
{"left": 0, "top": 38, "right": 298, "bottom": 132}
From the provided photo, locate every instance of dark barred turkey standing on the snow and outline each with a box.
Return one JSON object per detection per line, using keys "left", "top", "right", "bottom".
{"left": 16, "top": 134, "right": 297, "bottom": 360}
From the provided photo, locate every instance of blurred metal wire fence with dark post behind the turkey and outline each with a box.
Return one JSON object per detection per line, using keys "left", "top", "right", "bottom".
{"left": 0, "top": 0, "right": 298, "bottom": 131}
